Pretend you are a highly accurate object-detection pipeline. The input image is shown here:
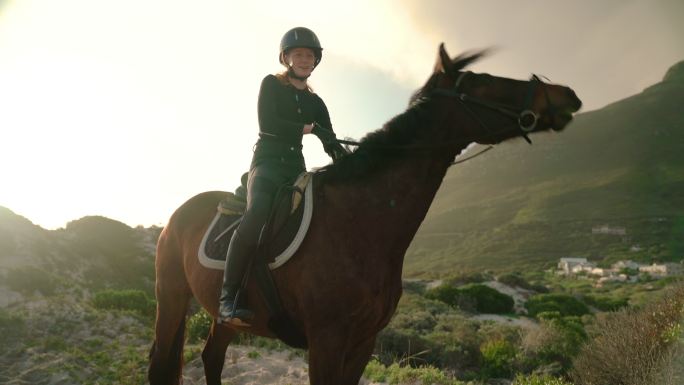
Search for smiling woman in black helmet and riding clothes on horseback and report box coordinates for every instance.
[219,27,346,326]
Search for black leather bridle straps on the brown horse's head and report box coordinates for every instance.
[431,71,553,144]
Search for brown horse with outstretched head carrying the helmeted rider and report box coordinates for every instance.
[149,45,581,385]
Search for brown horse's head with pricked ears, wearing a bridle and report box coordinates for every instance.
[416,44,582,144]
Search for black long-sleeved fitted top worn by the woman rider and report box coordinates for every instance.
[251,75,332,170]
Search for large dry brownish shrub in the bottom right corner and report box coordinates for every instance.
[571,284,684,385]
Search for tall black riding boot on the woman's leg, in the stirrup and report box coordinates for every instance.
[219,231,254,326]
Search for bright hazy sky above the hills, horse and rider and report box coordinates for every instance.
[0,0,684,229]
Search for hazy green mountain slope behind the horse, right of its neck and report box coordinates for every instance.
[405,62,684,276]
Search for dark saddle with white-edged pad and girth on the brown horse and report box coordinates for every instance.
[198,172,313,348]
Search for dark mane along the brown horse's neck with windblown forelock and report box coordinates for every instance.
[322,51,486,182]
